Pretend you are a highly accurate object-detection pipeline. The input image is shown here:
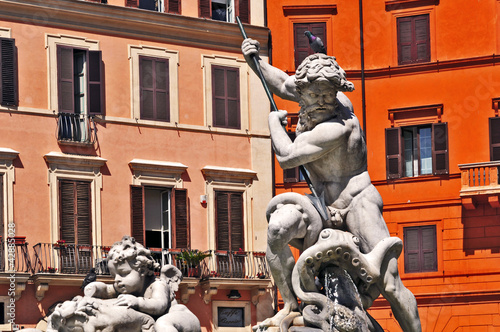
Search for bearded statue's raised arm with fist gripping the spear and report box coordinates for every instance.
[241,38,299,102]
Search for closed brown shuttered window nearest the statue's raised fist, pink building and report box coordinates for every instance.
[212,66,241,129]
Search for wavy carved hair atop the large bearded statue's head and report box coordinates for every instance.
[295,53,354,94]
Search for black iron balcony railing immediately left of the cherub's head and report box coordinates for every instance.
[33,242,110,275]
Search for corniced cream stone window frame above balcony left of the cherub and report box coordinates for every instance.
[44,152,107,245]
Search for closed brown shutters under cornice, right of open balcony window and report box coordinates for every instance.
[215,191,245,251]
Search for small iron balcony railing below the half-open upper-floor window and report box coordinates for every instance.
[57,113,96,144]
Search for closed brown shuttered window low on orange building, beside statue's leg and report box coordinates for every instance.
[403,225,437,273]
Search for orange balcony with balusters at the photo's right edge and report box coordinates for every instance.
[458,161,500,210]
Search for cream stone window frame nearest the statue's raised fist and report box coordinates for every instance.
[201,54,250,134]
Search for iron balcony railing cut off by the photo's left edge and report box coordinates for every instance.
[0,236,33,273]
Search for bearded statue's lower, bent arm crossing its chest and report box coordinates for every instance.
[269,111,350,169]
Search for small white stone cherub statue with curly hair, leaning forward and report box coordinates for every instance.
[47,236,201,332]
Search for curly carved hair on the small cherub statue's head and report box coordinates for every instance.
[108,236,160,276]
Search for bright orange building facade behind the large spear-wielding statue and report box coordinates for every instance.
[267,0,500,331]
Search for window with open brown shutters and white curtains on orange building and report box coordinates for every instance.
[386,123,448,179]
